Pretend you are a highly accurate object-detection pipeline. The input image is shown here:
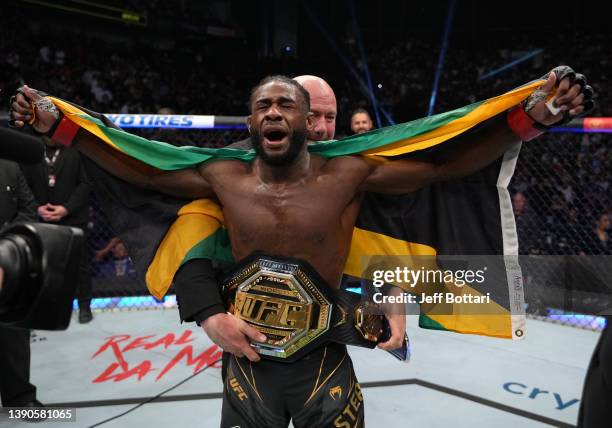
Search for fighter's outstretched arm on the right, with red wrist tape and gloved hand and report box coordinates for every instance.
[360,67,592,194]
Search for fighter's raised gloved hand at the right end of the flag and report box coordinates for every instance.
[525,66,594,126]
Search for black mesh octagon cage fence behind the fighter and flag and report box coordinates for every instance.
[80,114,612,330]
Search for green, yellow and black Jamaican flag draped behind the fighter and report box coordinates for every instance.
[50,80,544,338]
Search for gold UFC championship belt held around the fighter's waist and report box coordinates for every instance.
[222,253,408,362]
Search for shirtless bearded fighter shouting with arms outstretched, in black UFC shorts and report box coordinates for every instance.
[13,69,585,428]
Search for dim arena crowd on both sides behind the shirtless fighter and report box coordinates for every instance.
[0,2,612,292]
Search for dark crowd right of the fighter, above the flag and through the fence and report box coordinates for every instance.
[340,33,612,255]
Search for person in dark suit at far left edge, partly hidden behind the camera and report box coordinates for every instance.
[0,159,42,407]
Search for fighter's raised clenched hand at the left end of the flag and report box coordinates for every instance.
[10,85,57,134]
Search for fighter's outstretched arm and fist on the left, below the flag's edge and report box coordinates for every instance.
[11,86,213,199]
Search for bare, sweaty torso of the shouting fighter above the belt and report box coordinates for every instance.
[205,156,367,287]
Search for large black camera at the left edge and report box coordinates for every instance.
[0,223,85,330]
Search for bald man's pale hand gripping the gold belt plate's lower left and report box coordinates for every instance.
[202,313,266,362]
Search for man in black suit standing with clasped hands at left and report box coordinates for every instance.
[22,138,93,323]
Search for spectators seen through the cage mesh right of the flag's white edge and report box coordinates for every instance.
[510,133,612,255]
